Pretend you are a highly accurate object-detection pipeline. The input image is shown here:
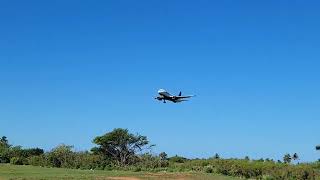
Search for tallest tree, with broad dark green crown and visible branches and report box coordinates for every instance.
[92,128,152,166]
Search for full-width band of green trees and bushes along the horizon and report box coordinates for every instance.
[0,129,320,179]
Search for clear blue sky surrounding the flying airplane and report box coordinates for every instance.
[0,0,320,161]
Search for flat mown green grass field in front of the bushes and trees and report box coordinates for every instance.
[0,164,235,180]
